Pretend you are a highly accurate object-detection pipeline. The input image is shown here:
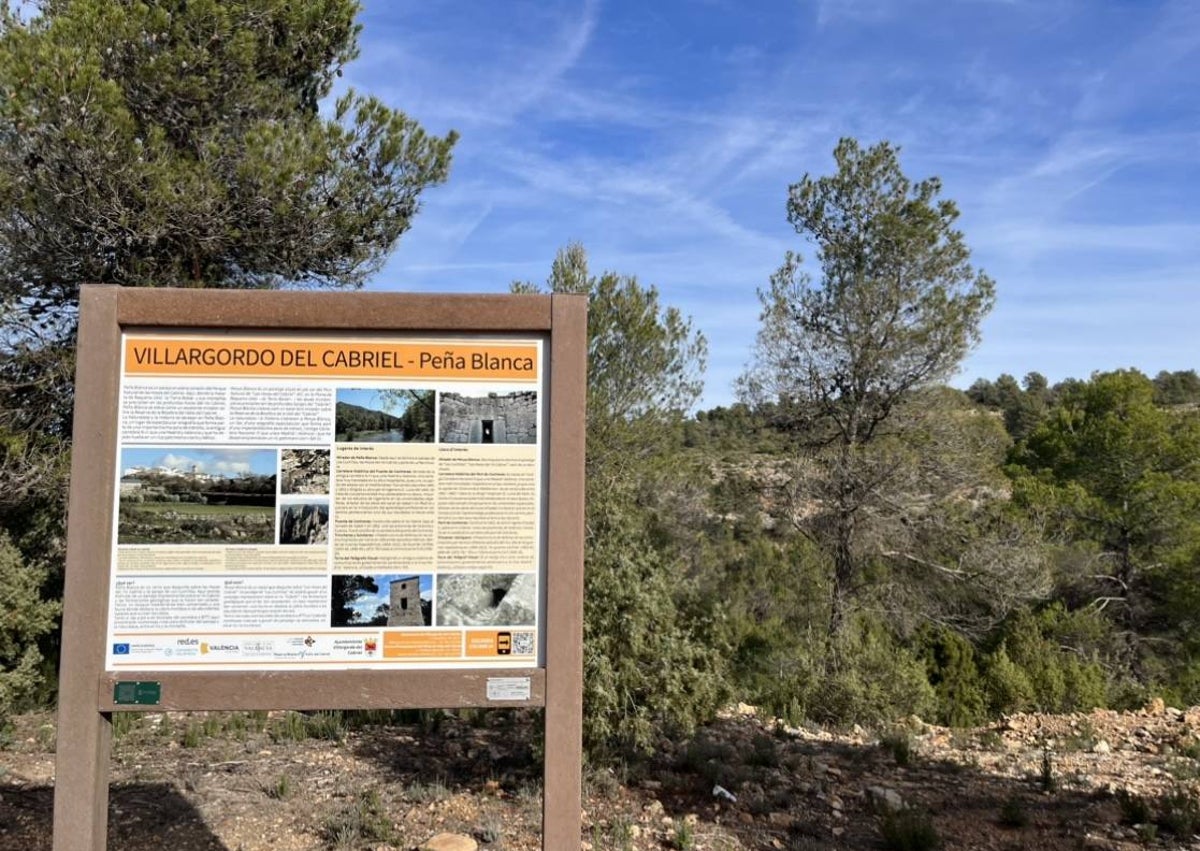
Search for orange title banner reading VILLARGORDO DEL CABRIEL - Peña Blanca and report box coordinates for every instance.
[125,337,538,382]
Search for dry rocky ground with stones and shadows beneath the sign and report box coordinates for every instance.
[0,703,1200,851]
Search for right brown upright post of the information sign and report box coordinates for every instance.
[541,295,588,850]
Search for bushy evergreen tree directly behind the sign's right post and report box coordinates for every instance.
[512,244,724,755]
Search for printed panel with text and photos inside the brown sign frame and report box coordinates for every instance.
[106,331,547,672]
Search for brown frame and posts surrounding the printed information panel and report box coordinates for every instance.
[53,286,587,851]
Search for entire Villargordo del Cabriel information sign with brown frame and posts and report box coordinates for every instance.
[53,286,587,851]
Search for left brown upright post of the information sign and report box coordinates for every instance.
[54,287,120,851]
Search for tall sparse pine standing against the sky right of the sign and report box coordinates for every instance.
[740,139,994,661]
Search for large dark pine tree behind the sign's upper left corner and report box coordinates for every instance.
[0,0,456,700]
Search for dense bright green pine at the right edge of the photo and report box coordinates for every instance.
[1013,370,1200,681]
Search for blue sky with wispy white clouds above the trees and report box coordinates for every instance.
[344,0,1200,406]
